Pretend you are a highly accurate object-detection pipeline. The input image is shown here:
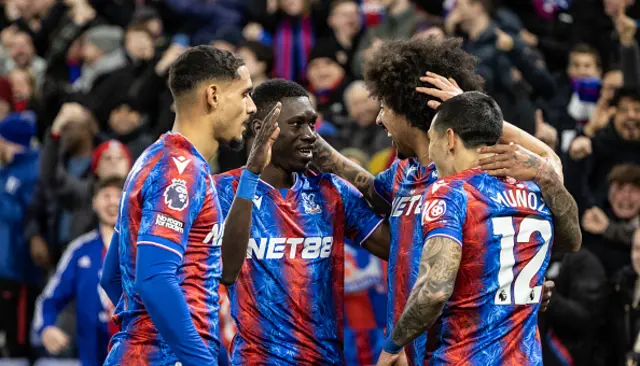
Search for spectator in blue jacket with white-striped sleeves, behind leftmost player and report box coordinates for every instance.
[33,176,124,365]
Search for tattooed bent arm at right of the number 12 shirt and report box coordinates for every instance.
[536,165,582,252]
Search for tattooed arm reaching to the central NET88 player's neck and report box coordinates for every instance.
[313,135,391,215]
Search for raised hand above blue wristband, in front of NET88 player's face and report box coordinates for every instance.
[247,102,282,174]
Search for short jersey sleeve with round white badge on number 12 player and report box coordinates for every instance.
[422,181,467,246]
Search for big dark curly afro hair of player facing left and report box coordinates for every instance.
[364,38,484,131]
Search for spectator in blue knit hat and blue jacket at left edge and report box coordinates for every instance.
[0,112,40,357]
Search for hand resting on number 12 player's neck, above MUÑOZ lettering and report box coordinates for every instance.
[478,143,555,181]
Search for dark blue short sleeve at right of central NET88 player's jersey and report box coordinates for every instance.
[334,177,383,245]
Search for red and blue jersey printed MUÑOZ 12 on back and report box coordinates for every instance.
[422,169,553,366]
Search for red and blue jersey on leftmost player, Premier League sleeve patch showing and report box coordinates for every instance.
[106,133,222,365]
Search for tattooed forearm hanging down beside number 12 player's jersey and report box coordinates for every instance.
[392,237,462,346]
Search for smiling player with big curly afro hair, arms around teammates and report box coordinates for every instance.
[313,38,559,365]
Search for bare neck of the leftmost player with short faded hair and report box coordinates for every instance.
[172,112,219,161]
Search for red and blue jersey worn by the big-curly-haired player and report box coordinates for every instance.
[374,158,437,365]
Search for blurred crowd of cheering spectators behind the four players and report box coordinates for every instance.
[0,0,640,365]
